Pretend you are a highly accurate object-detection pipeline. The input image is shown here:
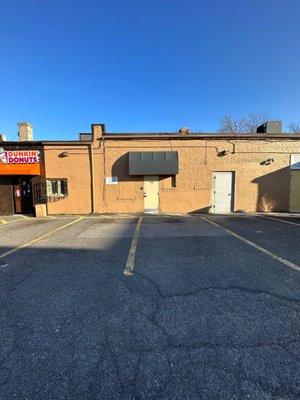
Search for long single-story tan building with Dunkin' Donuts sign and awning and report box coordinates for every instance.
[0,123,300,214]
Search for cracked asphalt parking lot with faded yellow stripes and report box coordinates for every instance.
[0,215,300,400]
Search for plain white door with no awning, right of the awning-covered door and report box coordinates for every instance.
[212,172,234,214]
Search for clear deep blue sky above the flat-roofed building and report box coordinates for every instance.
[0,0,300,139]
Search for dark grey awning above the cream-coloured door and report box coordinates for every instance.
[129,151,178,175]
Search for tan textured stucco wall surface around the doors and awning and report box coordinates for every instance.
[45,138,300,214]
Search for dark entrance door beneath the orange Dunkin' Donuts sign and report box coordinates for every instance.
[14,177,33,214]
